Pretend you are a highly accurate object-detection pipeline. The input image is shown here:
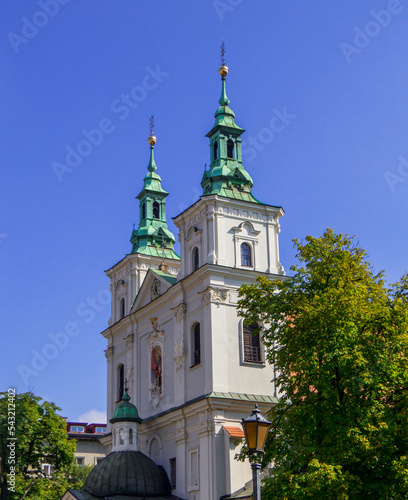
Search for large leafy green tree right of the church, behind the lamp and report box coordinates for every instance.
[239,229,408,500]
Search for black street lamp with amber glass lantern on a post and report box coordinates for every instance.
[242,405,271,500]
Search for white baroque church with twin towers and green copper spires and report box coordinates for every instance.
[102,65,284,500]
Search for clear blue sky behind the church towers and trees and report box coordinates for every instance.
[0,0,408,420]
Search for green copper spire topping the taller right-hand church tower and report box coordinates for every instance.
[201,47,259,203]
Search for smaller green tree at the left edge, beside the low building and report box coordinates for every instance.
[0,392,75,500]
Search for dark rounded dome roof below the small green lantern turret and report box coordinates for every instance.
[84,451,171,498]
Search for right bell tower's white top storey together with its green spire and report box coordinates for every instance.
[173,55,284,277]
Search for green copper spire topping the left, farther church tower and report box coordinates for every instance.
[130,120,180,260]
